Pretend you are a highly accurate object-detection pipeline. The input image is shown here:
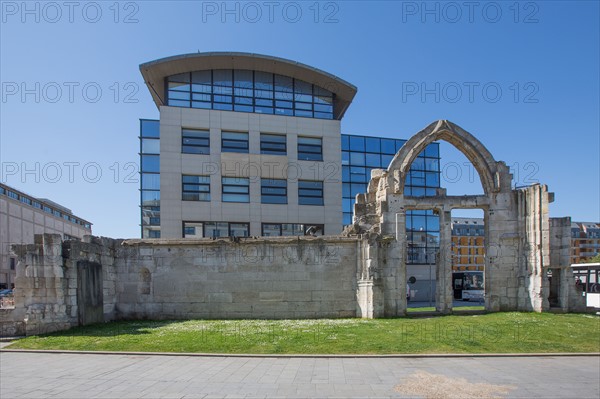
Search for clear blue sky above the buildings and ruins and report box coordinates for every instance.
[0,1,600,237]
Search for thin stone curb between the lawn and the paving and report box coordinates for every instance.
[0,349,600,359]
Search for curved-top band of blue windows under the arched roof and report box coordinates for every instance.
[166,69,334,119]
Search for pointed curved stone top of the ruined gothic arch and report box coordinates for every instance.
[387,120,510,195]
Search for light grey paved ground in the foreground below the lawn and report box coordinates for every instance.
[0,352,600,399]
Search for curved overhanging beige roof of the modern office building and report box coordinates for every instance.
[140,52,357,119]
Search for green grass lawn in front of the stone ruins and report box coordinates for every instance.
[8,312,600,354]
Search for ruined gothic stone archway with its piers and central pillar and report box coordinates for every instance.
[346,120,580,317]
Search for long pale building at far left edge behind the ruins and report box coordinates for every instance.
[0,184,92,289]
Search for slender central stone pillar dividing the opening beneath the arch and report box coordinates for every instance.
[435,209,454,313]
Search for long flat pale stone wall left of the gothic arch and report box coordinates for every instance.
[114,237,358,319]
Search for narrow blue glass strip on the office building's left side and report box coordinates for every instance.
[140,119,160,238]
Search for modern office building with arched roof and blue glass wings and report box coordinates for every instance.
[140,53,440,241]
